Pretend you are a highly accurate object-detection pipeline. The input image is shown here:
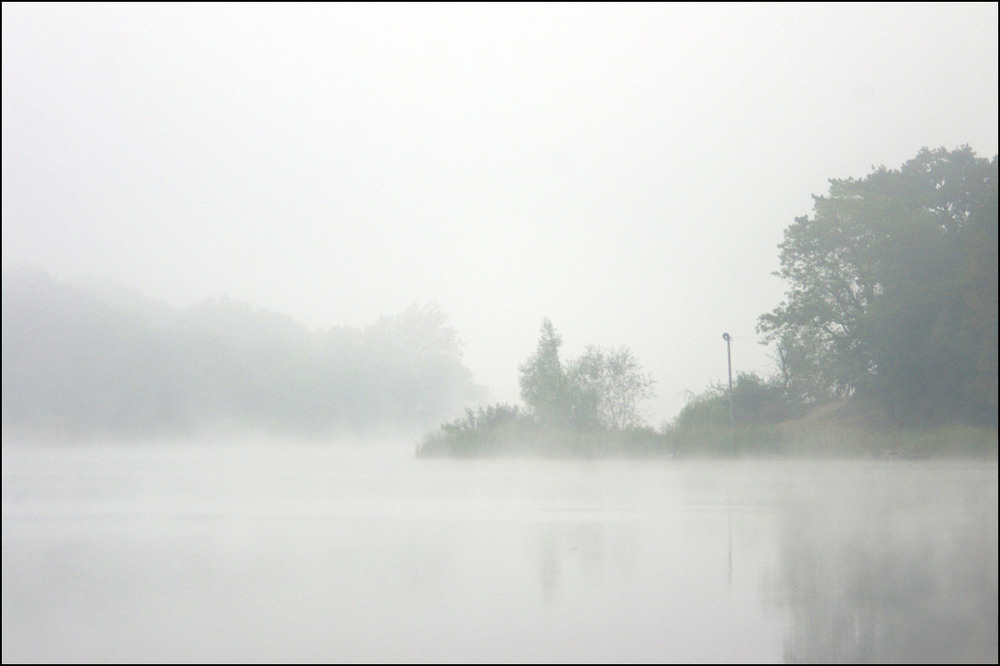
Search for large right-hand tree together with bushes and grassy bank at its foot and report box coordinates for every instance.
[664,147,997,456]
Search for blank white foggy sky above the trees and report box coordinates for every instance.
[3,3,998,424]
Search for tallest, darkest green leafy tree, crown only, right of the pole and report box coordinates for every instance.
[758,146,997,423]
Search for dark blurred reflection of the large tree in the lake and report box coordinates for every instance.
[770,465,998,663]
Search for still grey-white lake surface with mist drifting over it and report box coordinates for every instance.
[3,445,998,663]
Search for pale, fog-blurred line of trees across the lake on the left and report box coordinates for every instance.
[3,269,482,438]
